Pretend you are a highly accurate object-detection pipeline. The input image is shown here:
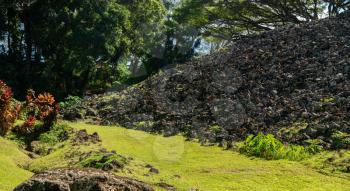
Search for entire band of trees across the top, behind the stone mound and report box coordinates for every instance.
[0,0,350,97]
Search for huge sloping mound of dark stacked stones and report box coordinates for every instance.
[63,13,350,147]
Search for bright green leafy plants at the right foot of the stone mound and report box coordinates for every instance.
[240,133,322,161]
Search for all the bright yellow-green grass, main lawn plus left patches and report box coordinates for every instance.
[0,123,350,191]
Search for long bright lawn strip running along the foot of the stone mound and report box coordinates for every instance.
[62,123,350,191]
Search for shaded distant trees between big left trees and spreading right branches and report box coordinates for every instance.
[137,0,201,76]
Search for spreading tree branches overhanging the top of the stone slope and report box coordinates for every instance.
[176,0,350,40]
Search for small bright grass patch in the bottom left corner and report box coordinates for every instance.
[0,137,32,191]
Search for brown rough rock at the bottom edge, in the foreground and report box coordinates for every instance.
[14,169,153,191]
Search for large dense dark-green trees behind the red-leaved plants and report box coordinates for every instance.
[0,0,164,97]
